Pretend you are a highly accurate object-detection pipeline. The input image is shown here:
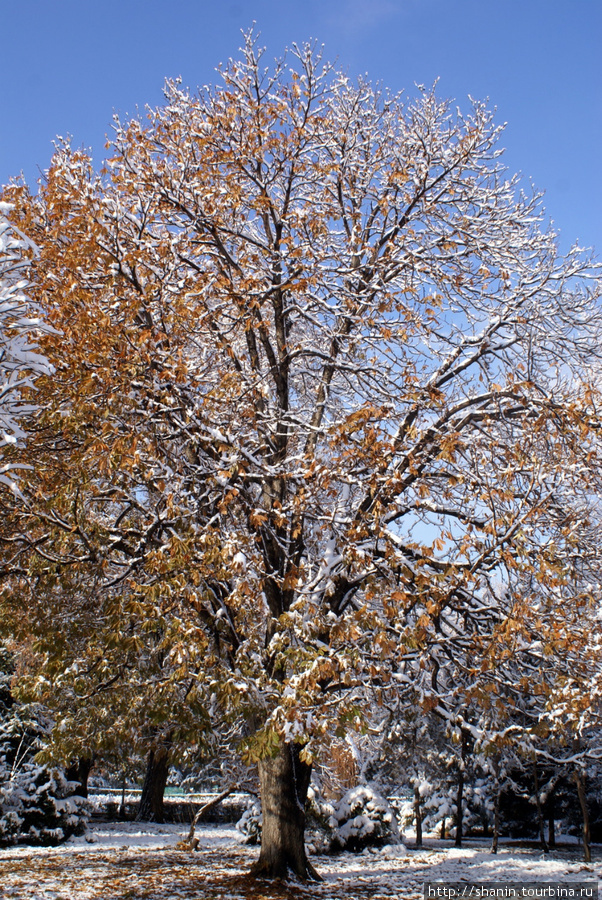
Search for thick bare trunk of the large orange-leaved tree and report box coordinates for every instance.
[251,744,320,881]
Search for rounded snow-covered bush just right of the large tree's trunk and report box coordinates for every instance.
[330,785,399,852]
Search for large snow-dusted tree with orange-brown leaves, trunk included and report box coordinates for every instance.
[2,37,600,877]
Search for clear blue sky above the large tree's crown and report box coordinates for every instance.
[0,0,602,255]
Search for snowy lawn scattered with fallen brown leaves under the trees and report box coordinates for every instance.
[0,823,602,900]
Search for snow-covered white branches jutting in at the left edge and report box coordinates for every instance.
[0,203,51,487]
